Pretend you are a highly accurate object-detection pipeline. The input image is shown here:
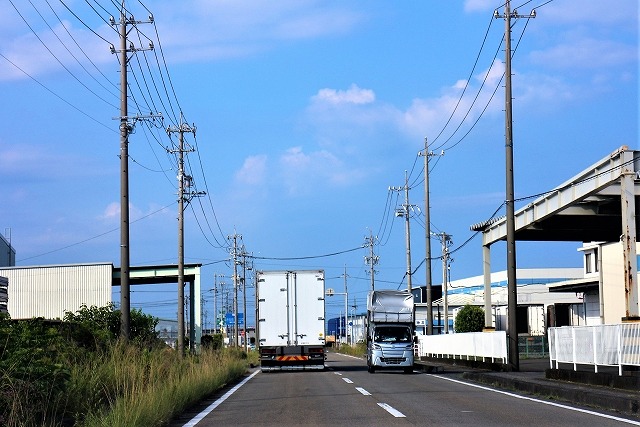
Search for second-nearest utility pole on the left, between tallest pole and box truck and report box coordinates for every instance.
[167,114,196,355]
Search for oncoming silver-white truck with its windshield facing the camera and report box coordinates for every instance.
[367,290,415,374]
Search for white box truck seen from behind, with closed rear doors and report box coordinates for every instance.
[256,270,325,371]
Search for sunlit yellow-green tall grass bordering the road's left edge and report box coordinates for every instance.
[77,346,248,427]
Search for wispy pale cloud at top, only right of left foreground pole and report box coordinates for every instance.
[154,0,364,62]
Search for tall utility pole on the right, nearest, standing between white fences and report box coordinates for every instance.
[493,0,536,371]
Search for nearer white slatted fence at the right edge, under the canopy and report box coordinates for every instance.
[549,323,640,375]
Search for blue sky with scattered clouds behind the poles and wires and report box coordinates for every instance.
[0,0,639,328]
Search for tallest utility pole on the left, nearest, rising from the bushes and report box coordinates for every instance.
[109,5,153,341]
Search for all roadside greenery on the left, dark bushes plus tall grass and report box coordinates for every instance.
[0,306,253,427]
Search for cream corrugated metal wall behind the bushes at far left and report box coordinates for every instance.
[0,264,113,319]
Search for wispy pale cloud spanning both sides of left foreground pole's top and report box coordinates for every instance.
[0,0,364,80]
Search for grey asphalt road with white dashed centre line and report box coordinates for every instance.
[172,354,640,427]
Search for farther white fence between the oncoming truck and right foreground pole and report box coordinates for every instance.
[417,331,507,363]
